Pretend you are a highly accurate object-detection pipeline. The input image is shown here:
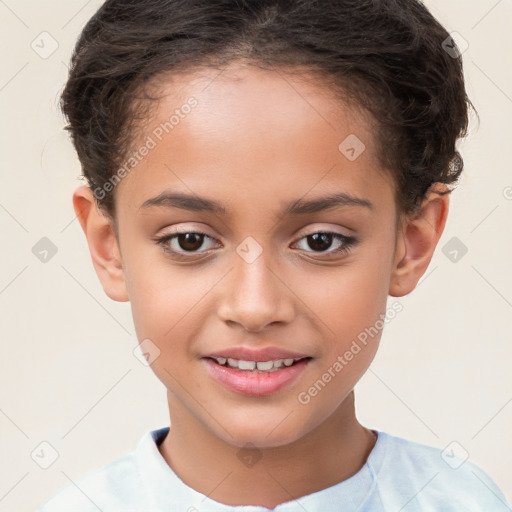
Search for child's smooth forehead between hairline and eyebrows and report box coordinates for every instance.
[116,65,391,215]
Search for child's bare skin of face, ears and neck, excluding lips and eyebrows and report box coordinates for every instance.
[73,64,449,508]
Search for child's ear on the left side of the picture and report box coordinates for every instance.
[73,185,129,302]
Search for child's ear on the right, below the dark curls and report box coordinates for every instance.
[389,183,450,297]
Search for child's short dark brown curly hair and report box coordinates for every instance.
[60,0,476,218]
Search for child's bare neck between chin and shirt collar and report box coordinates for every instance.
[159,392,376,508]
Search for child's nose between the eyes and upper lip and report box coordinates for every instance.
[218,250,295,332]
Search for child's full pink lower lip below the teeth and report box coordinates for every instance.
[204,358,310,396]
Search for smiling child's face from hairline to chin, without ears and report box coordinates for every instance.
[115,66,400,447]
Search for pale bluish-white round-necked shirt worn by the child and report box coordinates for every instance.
[38,427,512,512]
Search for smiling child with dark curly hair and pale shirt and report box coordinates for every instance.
[41,0,510,512]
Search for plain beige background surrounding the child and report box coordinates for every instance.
[0,0,512,512]
